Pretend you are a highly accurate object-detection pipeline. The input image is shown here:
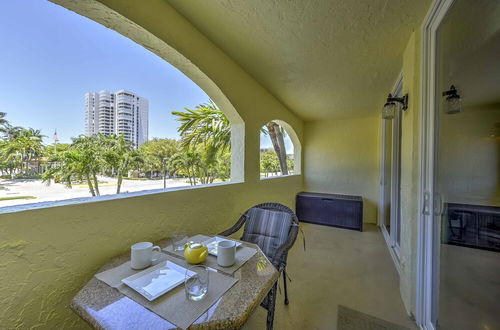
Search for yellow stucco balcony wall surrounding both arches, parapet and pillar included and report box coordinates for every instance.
[0,0,303,329]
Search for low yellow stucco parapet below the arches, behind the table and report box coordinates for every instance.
[0,176,302,329]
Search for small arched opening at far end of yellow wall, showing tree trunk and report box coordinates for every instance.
[260,120,301,178]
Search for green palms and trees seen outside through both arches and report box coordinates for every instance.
[0,101,293,196]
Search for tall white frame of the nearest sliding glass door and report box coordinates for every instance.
[415,0,455,330]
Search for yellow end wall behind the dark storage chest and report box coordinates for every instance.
[304,112,380,223]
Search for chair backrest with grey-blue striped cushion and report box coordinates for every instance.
[242,203,298,260]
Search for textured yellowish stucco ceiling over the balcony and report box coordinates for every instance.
[166,0,430,120]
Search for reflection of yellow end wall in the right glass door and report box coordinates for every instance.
[437,104,500,206]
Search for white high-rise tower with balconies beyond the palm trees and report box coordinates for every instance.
[85,90,149,148]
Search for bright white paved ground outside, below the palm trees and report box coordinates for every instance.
[0,177,189,207]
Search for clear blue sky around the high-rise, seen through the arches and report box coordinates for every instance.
[0,0,291,149]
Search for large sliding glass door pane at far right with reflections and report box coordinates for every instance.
[432,0,500,330]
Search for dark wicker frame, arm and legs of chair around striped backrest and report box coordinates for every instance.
[219,203,299,329]
